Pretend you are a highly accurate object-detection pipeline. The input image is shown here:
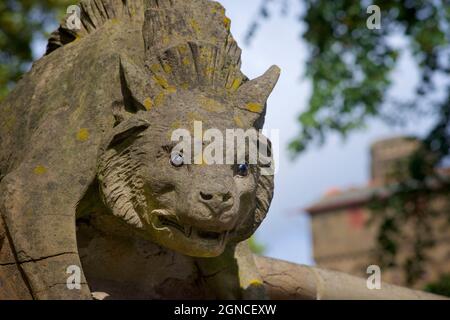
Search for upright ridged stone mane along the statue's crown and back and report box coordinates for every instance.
[47,0,248,90]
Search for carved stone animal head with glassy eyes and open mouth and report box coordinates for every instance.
[98,63,278,257]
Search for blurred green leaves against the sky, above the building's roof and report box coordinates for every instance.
[247,0,450,154]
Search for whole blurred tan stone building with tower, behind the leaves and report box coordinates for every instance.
[306,137,450,288]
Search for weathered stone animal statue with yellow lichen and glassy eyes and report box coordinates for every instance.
[0,0,279,299]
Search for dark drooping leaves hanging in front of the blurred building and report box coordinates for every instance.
[370,175,450,286]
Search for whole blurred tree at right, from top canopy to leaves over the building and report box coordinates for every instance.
[247,0,450,284]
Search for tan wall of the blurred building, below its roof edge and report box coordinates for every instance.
[312,197,450,289]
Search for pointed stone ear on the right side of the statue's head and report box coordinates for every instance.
[236,66,280,129]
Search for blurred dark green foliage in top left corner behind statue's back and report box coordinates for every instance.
[0,0,74,100]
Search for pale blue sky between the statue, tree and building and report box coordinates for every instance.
[34,0,427,264]
